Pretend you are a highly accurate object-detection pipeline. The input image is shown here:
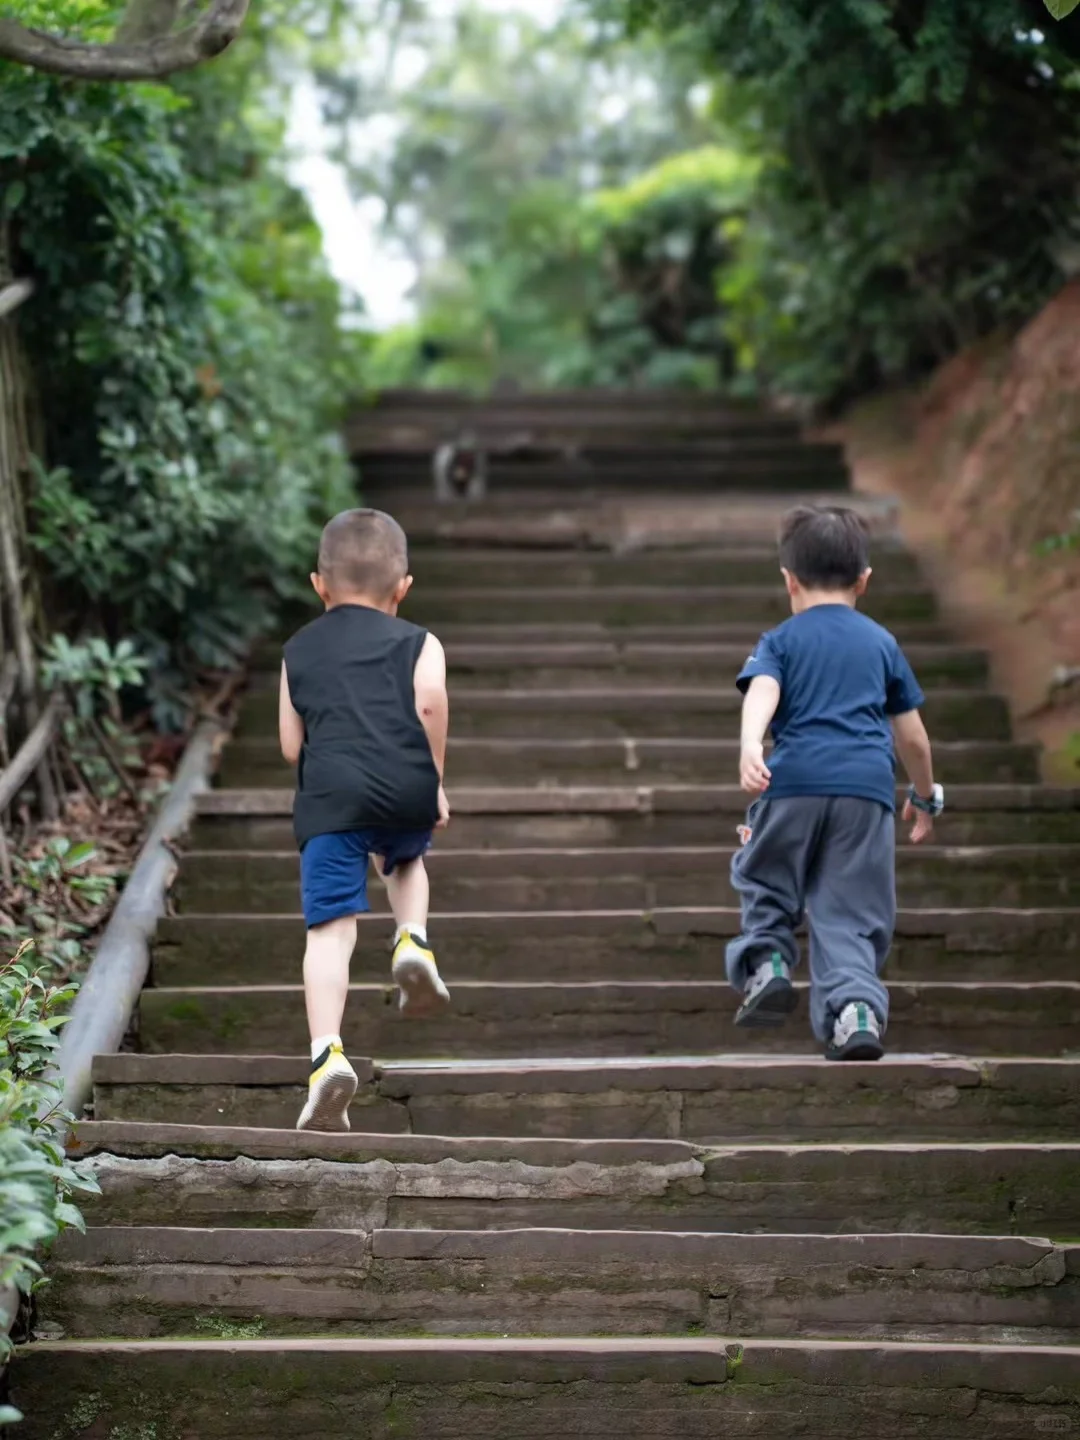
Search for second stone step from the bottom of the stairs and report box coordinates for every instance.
[40,1227,1080,1344]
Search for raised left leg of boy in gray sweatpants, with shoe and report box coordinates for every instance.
[727,795,824,1027]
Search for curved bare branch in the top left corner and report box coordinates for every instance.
[0,0,249,81]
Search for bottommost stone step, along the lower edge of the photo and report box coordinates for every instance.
[13,1338,1080,1440]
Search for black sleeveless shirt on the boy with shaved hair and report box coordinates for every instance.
[285,605,439,848]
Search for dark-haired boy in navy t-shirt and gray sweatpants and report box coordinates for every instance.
[727,507,943,1060]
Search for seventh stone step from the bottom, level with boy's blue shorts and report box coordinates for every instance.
[173,831,1080,916]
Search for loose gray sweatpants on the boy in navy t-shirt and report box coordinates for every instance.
[727,795,896,1041]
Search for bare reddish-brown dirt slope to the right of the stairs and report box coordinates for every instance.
[834,281,1080,783]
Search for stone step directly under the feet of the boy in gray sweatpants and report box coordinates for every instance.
[94,1054,1080,1143]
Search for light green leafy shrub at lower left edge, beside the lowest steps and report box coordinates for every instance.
[0,943,98,1382]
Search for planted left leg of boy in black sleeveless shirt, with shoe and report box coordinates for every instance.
[297,834,367,1130]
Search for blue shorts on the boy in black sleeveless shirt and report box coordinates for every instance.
[300,825,432,930]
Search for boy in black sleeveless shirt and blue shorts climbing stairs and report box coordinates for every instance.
[279,510,449,1130]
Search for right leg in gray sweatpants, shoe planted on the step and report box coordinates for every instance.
[806,795,896,1060]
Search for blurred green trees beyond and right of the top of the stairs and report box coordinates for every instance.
[342,0,1080,403]
